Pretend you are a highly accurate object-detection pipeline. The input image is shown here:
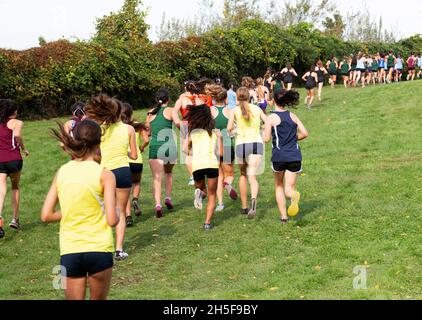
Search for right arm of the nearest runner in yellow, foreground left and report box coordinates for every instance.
[100,169,120,227]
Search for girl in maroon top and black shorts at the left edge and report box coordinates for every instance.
[0,99,29,239]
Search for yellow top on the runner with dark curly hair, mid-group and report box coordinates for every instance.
[190,129,219,172]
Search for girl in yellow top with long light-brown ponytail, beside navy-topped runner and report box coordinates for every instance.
[227,87,267,219]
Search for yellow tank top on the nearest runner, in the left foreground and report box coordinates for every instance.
[57,161,114,256]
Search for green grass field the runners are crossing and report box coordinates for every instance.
[0,81,422,300]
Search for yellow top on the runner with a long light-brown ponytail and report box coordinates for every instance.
[234,104,263,146]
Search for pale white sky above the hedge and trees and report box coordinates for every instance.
[0,0,422,50]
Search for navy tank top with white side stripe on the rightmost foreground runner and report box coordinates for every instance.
[272,111,302,163]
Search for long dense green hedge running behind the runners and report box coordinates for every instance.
[0,20,422,119]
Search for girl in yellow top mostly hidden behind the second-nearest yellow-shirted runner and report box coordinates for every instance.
[122,103,149,227]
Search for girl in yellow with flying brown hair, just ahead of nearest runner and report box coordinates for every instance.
[85,94,138,261]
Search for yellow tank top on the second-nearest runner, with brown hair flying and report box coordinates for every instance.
[101,122,129,170]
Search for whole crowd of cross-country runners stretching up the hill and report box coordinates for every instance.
[0,52,422,299]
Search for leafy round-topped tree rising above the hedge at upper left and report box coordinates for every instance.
[94,0,149,43]
